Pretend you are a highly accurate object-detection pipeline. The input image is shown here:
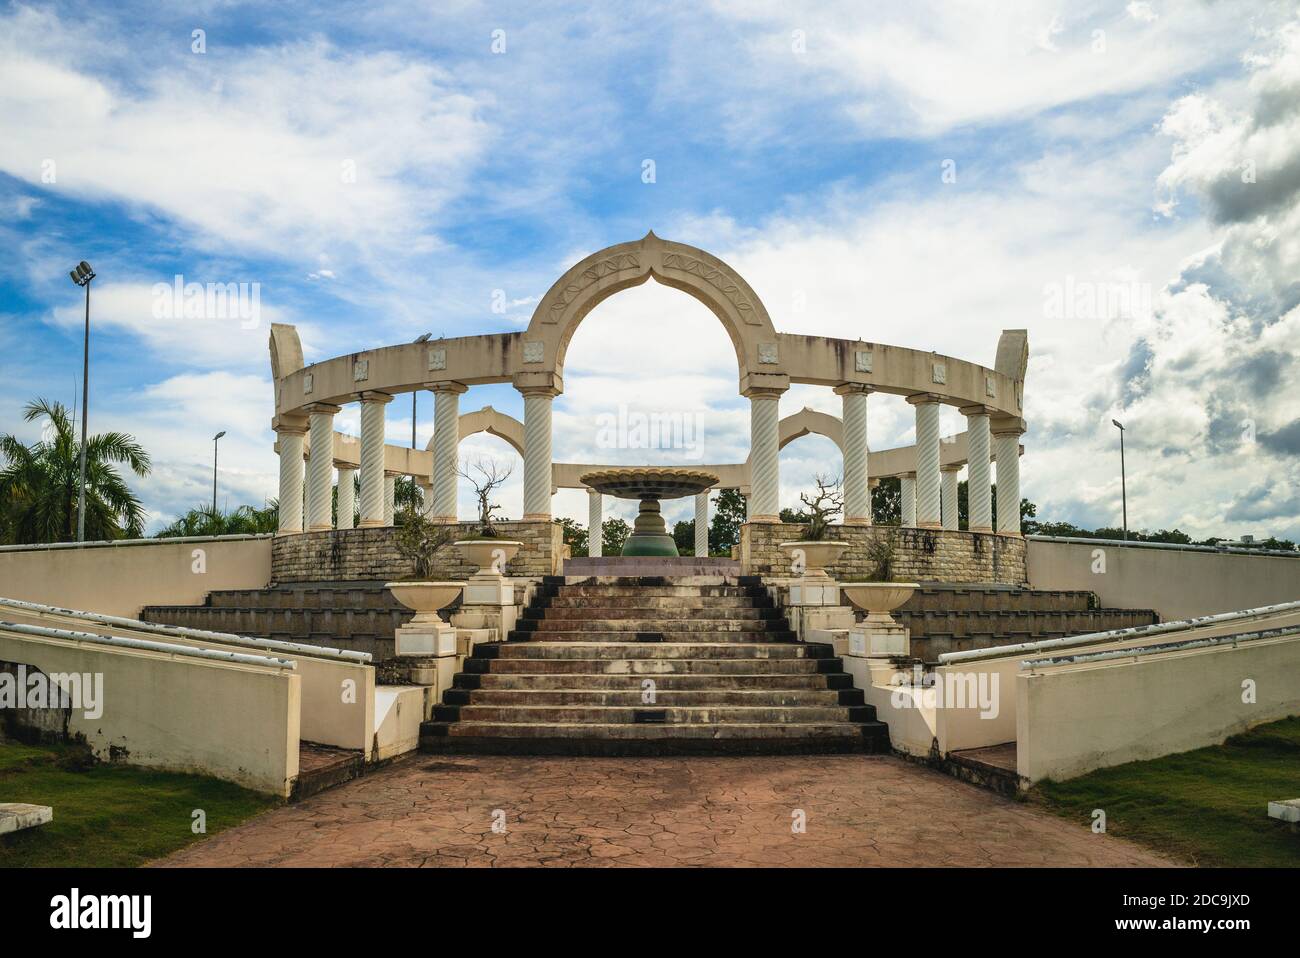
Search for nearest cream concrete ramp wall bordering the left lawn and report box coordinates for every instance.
[0,623,302,796]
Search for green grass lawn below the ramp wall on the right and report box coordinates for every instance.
[1030,716,1300,867]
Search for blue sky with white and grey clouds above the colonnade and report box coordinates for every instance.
[0,0,1300,538]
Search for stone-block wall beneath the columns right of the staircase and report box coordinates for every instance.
[740,523,1028,586]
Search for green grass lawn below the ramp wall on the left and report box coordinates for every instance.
[0,741,278,868]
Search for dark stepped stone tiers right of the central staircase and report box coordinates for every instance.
[894,585,1160,662]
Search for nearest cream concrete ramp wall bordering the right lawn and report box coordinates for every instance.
[1015,627,1300,783]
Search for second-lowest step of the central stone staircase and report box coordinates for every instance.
[434,705,876,725]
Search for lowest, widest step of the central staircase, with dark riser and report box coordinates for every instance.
[420,721,889,755]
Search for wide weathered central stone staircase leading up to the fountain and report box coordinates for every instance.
[420,576,889,755]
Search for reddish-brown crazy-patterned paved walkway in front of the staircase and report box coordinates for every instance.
[160,755,1171,867]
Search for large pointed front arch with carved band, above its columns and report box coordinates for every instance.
[524,230,781,381]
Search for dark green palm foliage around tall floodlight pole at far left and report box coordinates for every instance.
[0,399,150,542]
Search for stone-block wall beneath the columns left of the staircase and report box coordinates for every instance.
[270,521,563,585]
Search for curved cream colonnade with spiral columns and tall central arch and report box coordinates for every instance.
[270,233,1028,536]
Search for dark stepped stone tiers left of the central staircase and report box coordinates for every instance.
[140,582,415,662]
